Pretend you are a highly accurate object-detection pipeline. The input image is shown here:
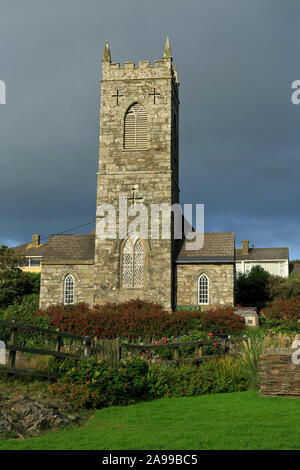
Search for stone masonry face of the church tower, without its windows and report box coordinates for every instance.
[94,54,179,308]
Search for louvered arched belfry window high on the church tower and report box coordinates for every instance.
[124,103,147,150]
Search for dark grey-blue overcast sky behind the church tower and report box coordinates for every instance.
[0,0,300,259]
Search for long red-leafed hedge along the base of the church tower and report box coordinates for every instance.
[37,300,201,340]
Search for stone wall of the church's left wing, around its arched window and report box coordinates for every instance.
[40,261,94,308]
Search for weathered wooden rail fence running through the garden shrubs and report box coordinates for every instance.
[0,320,229,378]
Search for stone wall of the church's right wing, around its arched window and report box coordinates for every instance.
[177,264,234,310]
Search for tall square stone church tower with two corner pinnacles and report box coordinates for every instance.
[94,39,179,309]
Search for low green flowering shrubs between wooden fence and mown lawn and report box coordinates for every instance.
[48,356,248,408]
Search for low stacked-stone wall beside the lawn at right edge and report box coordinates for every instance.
[259,348,300,397]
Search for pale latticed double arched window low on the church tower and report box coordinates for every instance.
[122,238,145,287]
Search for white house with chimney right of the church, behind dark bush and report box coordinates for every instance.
[235,240,289,277]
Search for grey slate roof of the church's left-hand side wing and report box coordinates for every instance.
[43,234,95,262]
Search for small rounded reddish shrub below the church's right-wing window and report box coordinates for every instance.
[201,306,246,336]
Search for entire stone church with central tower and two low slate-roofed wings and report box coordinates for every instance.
[40,39,235,310]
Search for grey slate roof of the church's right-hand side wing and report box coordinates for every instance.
[176,232,235,264]
